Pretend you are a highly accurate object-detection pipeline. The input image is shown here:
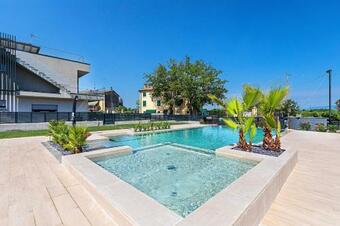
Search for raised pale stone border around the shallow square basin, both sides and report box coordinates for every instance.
[62,140,297,226]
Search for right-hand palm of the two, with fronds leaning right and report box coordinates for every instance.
[259,86,289,150]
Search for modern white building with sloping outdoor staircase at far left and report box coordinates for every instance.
[0,33,98,112]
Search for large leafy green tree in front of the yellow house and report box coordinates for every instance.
[146,57,227,114]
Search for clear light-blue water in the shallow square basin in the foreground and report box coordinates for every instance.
[93,144,257,217]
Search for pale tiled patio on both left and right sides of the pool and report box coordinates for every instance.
[0,128,340,226]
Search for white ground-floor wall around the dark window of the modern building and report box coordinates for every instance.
[18,97,88,112]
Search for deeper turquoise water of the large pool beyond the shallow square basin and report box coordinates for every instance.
[92,126,263,150]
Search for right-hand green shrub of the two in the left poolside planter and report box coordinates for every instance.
[63,126,90,153]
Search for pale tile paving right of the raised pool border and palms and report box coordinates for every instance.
[261,131,340,226]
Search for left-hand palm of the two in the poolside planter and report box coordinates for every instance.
[208,85,262,150]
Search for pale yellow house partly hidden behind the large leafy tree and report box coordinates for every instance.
[139,85,189,115]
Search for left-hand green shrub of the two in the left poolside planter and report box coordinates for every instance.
[48,120,69,147]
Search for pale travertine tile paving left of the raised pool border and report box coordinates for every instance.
[0,137,117,226]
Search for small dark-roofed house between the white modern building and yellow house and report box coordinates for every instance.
[80,88,123,113]
